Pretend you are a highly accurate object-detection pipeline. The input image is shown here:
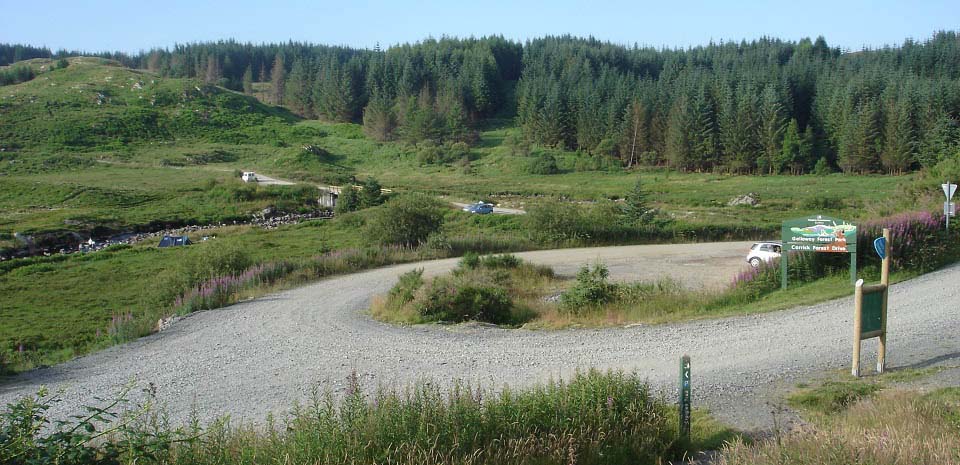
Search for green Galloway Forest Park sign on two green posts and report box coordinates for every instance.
[780,215,857,289]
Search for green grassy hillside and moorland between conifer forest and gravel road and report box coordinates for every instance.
[0,58,928,374]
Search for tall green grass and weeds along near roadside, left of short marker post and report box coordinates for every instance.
[0,371,685,465]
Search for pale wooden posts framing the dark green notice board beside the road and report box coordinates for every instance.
[850,229,890,376]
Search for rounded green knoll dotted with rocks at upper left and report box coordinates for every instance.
[0,57,296,151]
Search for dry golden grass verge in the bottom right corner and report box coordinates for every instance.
[717,372,960,465]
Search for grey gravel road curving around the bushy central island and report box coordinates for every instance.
[0,243,960,429]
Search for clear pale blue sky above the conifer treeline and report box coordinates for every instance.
[0,0,960,53]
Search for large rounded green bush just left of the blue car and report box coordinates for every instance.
[366,194,443,247]
